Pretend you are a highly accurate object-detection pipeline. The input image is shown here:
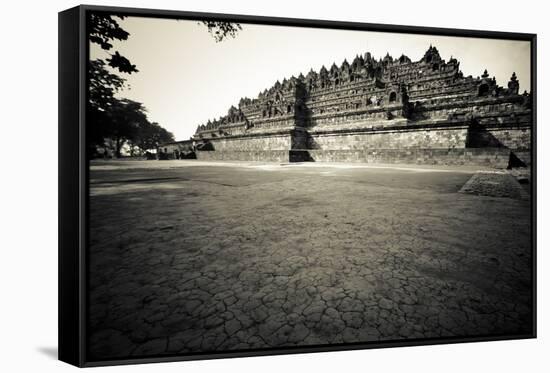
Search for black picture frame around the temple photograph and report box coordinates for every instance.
[58,5,537,367]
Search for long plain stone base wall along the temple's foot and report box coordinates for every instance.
[197,124,530,168]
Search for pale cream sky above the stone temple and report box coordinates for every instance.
[90,17,530,140]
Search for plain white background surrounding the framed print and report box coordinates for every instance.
[0,0,550,373]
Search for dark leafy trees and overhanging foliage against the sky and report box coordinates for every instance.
[87,13,241,157]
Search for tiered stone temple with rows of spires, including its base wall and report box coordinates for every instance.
[188,46,532,168]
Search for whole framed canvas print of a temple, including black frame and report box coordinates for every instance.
[59,6,536,366]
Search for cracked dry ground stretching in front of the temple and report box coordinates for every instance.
[88,162,532,359]
